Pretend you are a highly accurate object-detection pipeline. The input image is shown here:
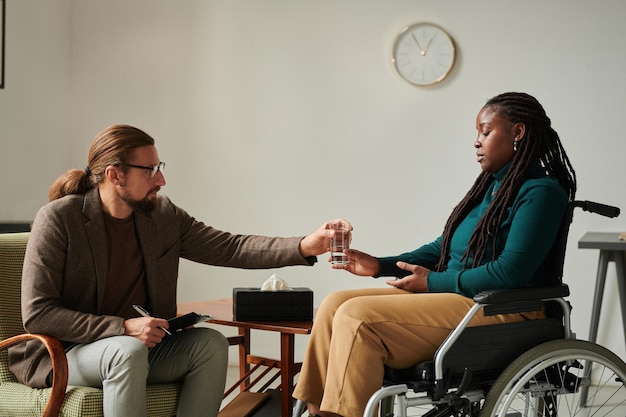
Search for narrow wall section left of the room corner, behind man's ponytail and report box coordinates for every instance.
[0,0,73,221]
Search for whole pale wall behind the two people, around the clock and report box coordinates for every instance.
[0,0,626,357]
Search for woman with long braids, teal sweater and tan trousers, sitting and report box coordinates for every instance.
[294,93,576,416]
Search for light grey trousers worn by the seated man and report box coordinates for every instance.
[67,328,228,417]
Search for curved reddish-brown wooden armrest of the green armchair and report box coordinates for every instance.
[0,333,68,417]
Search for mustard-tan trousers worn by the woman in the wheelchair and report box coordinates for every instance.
[293,287,544,417]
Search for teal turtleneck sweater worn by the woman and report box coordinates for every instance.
[378,165,568,297]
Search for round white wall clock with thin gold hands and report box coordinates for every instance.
[392,23,455,86]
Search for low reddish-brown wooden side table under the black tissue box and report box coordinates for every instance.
[178,298,313,417]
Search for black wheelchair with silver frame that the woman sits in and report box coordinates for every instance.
[293,200,626,417]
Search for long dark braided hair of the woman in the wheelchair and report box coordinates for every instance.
[436,93,576,271]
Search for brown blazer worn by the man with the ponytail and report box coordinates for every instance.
[9,188,316,387]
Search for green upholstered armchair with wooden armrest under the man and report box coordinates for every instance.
[0,233,181,417]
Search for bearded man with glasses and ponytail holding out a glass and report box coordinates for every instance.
[9,125,346,417]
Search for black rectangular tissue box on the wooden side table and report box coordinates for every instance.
[233,287,313,321]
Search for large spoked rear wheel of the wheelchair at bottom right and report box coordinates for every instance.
[480,339,626,417]
